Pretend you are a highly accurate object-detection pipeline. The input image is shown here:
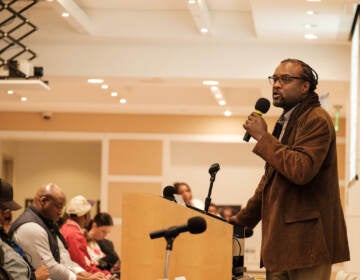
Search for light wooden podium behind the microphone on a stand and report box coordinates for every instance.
[121,193,233,280]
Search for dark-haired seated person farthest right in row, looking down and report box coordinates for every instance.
[87,213,120,274]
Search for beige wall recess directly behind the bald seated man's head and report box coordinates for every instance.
[3,141,101,220]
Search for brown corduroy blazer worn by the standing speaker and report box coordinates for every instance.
[236,107,350,271]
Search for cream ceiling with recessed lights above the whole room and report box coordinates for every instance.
[0,0,358,115]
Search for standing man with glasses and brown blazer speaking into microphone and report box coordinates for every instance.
[231,59,350,280]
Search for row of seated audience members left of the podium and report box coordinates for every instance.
[0,179,120,280]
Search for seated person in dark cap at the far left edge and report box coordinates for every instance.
[0,179,49,280]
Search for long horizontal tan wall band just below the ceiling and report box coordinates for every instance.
[0,112,248,134]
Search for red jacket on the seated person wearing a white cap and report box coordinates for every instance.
[60,218,110,274]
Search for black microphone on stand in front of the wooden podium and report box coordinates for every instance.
[150,216,206,239]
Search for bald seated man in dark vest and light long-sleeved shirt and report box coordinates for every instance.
[9,183,108,280]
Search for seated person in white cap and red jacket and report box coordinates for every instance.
[60,195,109,275]
